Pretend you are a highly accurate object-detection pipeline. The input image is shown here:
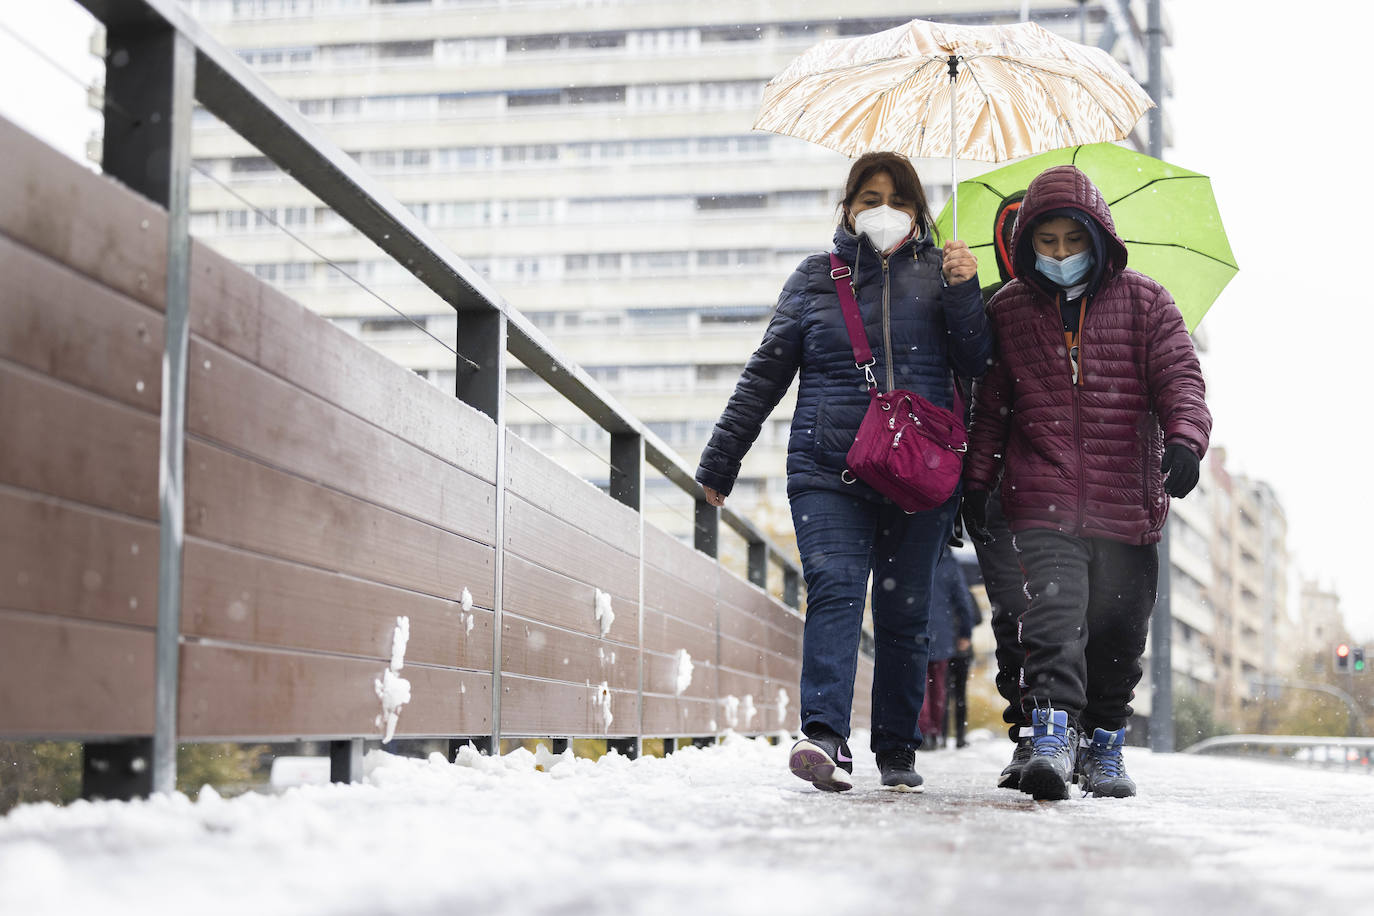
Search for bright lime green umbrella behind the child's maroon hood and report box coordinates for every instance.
[936,143,1237,331]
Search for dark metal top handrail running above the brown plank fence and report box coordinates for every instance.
[78,0,801,590]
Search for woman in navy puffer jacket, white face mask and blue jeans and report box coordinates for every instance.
[697,152,992,791]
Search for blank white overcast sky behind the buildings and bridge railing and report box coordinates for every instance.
[8,0,1374,641]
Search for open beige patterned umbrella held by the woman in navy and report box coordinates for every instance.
[754,19,1154,238]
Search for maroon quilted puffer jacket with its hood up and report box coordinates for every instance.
[965,165,1212,544]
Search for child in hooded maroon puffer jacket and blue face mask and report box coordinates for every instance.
[963,166,1212,799]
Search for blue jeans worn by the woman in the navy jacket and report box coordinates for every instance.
[791,490,959,753]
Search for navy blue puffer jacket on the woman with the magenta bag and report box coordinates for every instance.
[697,224,992,500]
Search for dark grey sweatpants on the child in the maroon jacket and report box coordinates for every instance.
[1014,529,1160,735]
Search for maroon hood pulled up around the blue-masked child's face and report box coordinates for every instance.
[1011,165,1127,299]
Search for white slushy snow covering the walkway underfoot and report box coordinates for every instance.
[0,735,1374,916]
